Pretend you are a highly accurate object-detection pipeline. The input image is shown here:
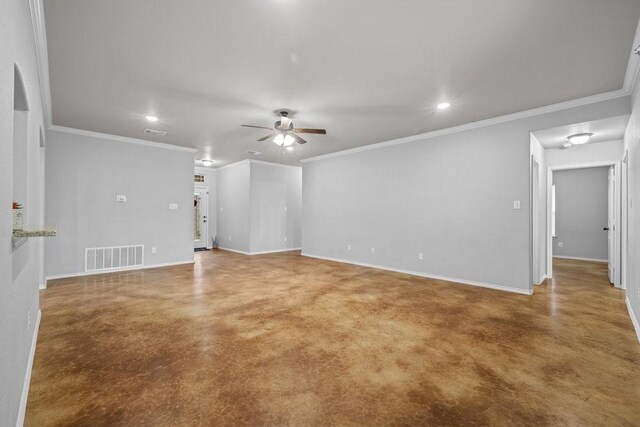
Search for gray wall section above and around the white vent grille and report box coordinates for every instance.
[45,131,194,277]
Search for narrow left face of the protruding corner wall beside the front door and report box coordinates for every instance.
[217,160,251,252]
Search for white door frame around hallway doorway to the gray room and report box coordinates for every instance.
[546,160,627,288]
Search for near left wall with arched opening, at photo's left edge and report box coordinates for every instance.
[0,0,45,425]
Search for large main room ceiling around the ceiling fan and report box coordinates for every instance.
[44,0,640,167]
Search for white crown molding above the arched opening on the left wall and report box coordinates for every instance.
[29,0,53,127]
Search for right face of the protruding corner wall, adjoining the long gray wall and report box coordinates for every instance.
[250,161,302,253]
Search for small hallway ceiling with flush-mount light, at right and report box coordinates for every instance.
[532,115,629,148]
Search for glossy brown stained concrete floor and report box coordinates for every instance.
[26,251,640,426]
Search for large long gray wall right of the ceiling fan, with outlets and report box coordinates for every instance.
[302,97,630,292]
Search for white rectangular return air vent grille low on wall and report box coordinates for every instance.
[84,245,144,272]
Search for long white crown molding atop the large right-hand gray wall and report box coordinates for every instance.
[300,89,630,163]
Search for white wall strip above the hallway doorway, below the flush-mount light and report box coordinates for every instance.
[545,141,624,167]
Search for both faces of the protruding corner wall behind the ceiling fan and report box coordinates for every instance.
[217,160,302,254]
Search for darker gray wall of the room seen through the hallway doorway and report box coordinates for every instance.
[553,167,609,261]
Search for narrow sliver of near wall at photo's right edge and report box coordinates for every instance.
[622,72,640,339]
